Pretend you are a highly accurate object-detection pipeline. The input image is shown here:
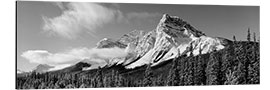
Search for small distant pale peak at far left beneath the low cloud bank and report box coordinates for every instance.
[33,64,54,73]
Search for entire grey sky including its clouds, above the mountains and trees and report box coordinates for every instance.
[16,1,260,71]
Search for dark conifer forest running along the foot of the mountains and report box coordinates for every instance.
[16,29,260,89]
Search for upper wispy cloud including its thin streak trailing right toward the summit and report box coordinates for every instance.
[43,2,161,39]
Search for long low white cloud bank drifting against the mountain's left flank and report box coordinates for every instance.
[21,47,127,68]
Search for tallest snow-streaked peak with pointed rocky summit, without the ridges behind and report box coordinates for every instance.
[126,14,230,68]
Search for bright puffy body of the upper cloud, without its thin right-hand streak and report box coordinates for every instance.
[43,2,121,39]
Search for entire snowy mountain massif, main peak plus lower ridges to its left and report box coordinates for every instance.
[94,14,230,69]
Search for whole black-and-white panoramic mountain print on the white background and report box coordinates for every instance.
[16,1,260,89]
